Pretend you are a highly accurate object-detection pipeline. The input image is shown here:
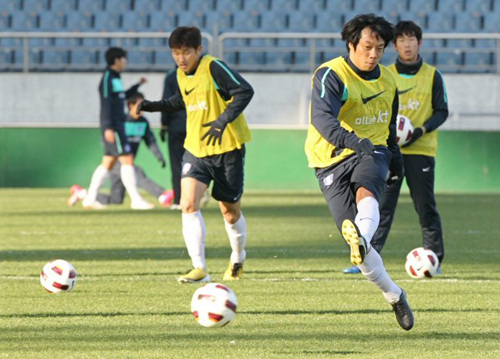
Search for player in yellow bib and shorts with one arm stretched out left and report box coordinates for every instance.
[138,27,253,283]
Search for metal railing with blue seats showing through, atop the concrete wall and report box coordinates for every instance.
[0,32,500,74]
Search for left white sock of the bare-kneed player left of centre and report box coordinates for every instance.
[182,211,207,269]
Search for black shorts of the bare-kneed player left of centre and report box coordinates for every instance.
[182,146,245,203]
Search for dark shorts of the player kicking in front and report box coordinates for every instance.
[316,147,392,228]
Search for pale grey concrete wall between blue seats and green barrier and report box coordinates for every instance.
[0,73,500,131]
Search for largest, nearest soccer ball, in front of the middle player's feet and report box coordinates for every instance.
[191,283,238,328]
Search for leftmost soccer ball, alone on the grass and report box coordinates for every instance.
[40,259,76,293]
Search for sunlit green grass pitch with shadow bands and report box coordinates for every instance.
[0,189,500,359]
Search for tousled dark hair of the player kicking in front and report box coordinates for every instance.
[340,14,394,51]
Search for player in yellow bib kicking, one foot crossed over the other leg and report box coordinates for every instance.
[305,14,414,330]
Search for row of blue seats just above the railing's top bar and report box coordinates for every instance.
[0,8,500,35]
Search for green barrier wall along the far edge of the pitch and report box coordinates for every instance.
[0,127,500,193]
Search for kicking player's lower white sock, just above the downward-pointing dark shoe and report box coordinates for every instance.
[358,249,401,303]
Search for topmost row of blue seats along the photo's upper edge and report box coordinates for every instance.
[2,0,500,13]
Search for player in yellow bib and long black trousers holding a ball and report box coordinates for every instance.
[372,21,448,274]
